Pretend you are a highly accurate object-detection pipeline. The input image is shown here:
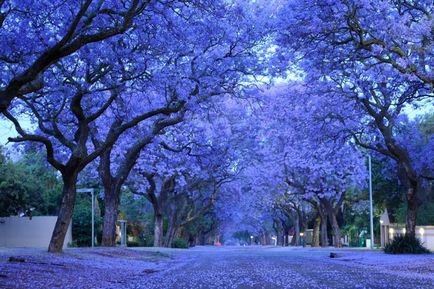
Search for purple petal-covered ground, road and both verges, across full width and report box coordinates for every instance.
[0,246,434,289]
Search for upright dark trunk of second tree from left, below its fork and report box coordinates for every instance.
[102,186,120,247]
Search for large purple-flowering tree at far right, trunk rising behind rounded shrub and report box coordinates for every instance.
[278,1,434,235]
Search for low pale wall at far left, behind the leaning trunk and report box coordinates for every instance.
[0,216,72,248]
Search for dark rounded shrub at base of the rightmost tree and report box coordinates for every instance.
[384,235,430,254]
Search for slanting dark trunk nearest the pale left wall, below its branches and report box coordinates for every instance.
[48,171,78,253]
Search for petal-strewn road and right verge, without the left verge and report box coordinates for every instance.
[133,247,434,289]
